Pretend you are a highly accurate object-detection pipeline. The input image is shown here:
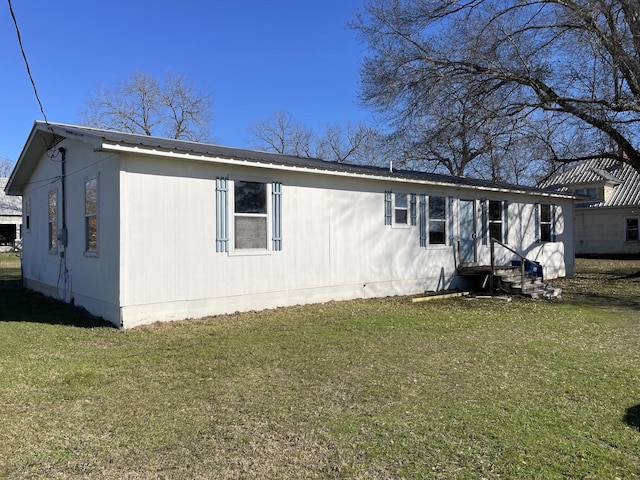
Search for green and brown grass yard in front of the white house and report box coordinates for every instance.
[0,260,640,479]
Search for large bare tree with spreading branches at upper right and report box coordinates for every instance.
[354,0,640,176]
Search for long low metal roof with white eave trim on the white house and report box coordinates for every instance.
[7,121,570,201]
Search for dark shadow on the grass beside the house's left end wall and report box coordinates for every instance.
[0,280,115,328]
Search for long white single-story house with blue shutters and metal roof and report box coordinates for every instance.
[6,122,574,328]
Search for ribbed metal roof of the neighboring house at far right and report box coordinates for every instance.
[541,158,640,207]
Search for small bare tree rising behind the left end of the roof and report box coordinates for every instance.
[82,72,212,141]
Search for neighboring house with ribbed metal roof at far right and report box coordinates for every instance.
[542,159,640,256]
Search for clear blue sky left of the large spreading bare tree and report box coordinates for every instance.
[0,0,371,161]
